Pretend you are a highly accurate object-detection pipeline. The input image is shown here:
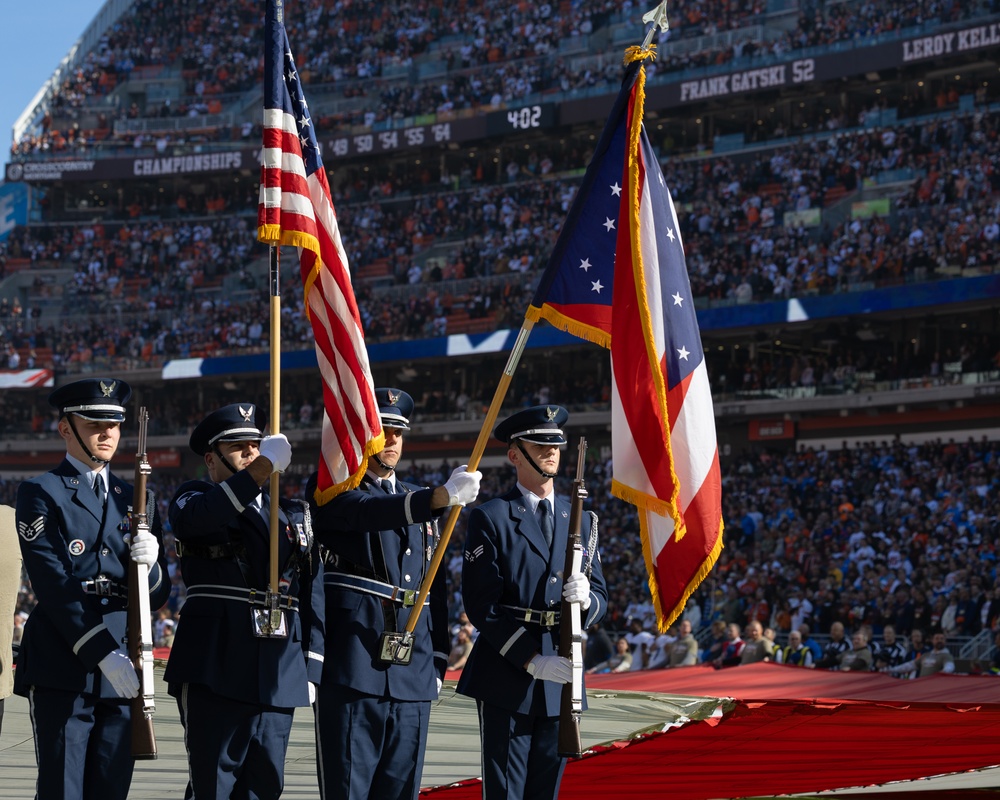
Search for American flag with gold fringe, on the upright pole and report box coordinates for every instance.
[257,0,385,504]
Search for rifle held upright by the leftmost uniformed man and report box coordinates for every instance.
[127,406,156,760]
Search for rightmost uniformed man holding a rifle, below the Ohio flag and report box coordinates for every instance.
[458,406,608,800]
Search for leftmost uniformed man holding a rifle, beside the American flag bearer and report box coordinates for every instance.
[14,378,170,800]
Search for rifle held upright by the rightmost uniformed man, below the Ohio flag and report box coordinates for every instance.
[559,437,587,758]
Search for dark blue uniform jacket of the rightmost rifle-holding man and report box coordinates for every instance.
[458,488,608,717]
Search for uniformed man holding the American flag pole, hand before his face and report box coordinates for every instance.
[164,403,322,800]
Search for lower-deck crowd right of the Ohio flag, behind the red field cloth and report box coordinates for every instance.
[592,440,1000,675]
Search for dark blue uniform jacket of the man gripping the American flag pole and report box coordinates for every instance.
[164,471,323,708]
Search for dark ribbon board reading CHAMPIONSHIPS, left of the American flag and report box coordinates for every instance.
[6,148,258,183]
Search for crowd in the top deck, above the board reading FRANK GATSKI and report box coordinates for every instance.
[11,0,998,156]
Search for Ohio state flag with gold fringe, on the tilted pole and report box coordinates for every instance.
[527,48,722,628]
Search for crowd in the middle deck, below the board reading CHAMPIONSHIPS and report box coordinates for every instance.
[0,97,1000,389]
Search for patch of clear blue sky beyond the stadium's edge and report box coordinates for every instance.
[0,0,104,153]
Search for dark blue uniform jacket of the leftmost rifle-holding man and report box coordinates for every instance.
[14,460,170,700]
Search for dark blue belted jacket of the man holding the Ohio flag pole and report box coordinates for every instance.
[313,476,450,701]
